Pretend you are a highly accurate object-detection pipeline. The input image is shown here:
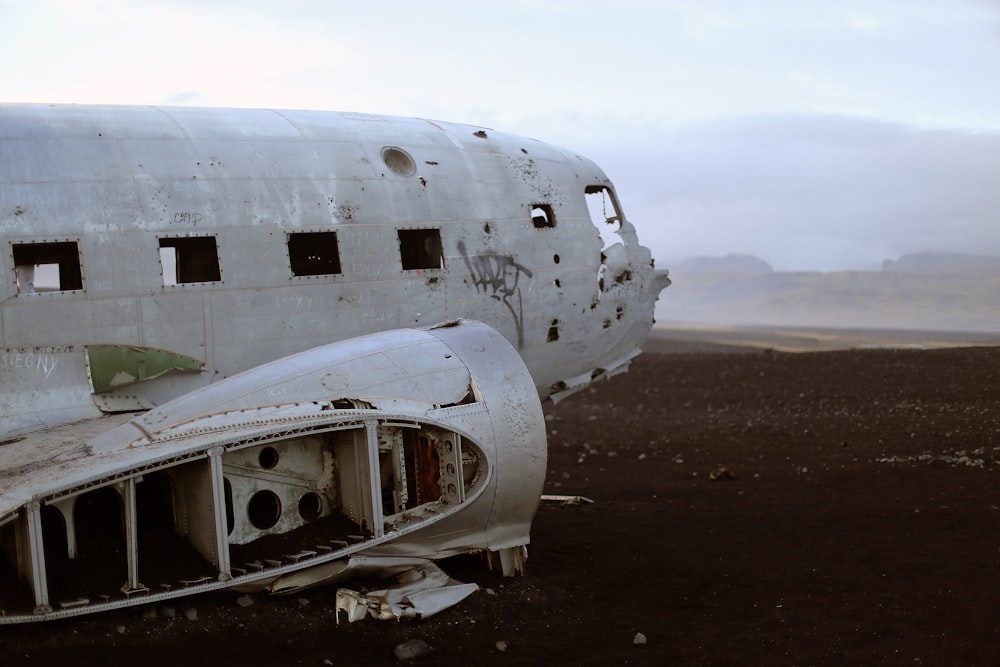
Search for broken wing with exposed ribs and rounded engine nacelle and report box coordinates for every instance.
[0,322,546,623]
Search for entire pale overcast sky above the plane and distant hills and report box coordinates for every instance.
[0,0,1000,270]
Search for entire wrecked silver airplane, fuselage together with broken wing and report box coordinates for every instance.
[0,104,669,623]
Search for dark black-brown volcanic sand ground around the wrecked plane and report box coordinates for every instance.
[0,343,1000,667]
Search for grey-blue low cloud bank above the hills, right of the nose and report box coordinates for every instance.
[619,115,1000,270]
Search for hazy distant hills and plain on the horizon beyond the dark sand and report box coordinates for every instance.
[656,252,1000,332]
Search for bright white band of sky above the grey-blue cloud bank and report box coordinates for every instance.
[7,0,1000,129]
